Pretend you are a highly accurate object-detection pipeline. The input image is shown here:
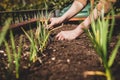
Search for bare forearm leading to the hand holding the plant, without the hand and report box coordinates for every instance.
[61,0,85,21]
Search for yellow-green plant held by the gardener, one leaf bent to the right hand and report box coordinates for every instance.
[35,10,62,53]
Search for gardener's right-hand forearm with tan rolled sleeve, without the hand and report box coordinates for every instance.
[79,0,116,28]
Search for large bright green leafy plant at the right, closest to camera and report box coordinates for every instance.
[85,10,120,80]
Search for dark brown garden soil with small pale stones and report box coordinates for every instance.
[0,21,120,80]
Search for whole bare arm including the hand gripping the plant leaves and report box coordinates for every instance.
[49,0,87,28]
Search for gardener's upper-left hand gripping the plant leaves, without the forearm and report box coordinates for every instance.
[48,17,63,29]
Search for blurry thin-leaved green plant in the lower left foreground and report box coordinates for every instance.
[4,31,22,78]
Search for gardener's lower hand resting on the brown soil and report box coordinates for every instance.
[56,28,83,40]
